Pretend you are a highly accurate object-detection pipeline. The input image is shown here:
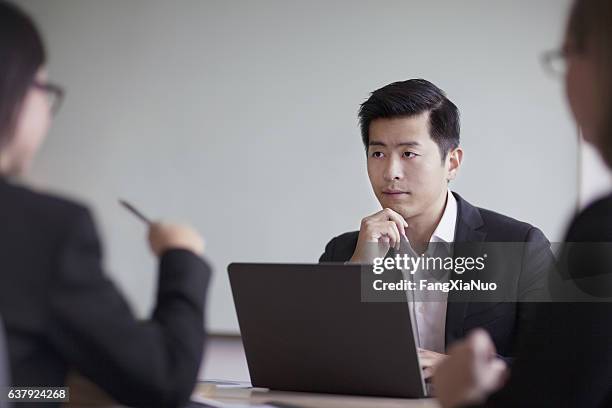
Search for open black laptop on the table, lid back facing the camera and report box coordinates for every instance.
[228,263,427,398]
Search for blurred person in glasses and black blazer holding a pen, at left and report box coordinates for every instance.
[0,1,210,407]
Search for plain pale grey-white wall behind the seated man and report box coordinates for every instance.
[16,0,577,332]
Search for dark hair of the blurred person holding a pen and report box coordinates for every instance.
[0,0,46,150]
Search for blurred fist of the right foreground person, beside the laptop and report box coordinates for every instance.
[433,329,508,408]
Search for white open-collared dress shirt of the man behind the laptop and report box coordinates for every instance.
[408,190,457,353]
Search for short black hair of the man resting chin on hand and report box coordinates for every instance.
[359,79,460,160]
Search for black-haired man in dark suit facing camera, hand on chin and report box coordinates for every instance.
[319,79,552,376]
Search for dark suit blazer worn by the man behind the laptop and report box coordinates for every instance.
[319,193,553,357]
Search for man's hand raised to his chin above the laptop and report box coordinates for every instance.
[349,208,408,263]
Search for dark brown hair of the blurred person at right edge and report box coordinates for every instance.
[567,0,612,169]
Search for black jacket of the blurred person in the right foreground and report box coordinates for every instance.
[484,195,612,408]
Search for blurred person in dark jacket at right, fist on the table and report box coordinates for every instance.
[434,0,612,408]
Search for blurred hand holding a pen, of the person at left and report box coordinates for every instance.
[149,222,204,256]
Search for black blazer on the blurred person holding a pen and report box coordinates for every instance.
[0,179,210,407]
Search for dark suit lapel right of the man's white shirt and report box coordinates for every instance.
[445,192,487,347]
